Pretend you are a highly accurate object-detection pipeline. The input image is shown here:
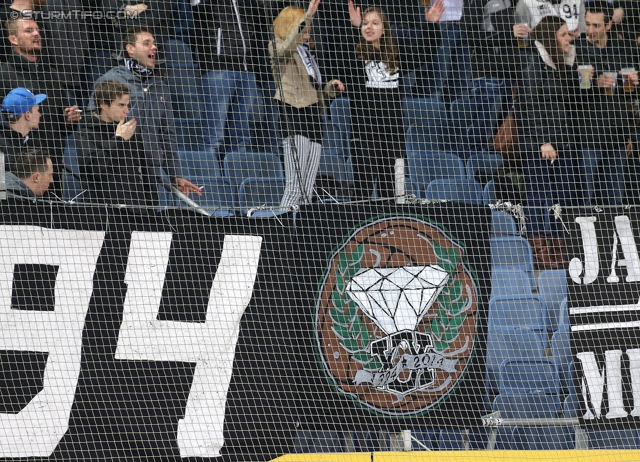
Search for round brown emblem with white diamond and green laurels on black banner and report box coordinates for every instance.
[315,217,477,415]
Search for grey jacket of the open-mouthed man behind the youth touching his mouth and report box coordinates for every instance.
[88,66,182,181]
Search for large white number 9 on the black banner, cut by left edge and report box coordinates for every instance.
[0,226,104,457]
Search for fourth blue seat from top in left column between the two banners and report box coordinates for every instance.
[489,294,546,334]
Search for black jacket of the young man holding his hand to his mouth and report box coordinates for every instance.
[75,114,158,207]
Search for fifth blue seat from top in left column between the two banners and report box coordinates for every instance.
[486,326,544,393]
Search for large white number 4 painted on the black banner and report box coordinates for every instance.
[116,232,262,457]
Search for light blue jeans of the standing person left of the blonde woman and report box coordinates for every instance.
[202,71,259,153]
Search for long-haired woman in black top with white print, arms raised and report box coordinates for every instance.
[340,0,444,199]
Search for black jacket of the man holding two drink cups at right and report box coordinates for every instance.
[575,35,638,150]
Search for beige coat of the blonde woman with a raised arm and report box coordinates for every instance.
[269,13,337,110]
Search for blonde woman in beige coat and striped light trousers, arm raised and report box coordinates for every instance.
[269,0,344,207]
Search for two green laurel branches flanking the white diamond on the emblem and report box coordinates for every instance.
[329,242,468,371]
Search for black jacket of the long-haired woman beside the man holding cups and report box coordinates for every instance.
[514,45,580,158]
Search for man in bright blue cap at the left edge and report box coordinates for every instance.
[0,87,47,170]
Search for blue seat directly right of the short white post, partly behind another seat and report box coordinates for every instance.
[407,151,465,199]
